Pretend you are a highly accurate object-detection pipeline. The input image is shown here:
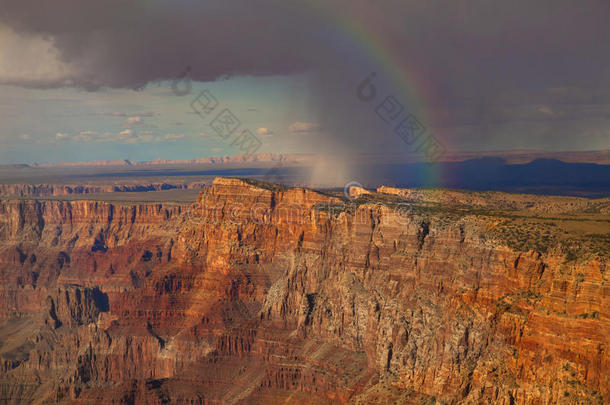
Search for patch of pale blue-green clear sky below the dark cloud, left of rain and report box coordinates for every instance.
[0,72,315,163]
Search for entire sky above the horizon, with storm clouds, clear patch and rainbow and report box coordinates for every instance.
[0,0,610,164]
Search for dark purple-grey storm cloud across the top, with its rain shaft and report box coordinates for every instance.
[0,0,610,153]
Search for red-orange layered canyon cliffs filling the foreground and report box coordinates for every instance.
[0,177,610,404]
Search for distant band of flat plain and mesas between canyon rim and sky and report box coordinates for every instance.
[0,151,610,198]
